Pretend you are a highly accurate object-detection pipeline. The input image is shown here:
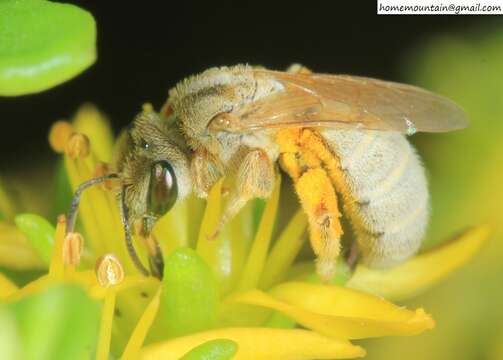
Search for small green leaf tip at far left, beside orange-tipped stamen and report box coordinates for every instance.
[14,214,56,265]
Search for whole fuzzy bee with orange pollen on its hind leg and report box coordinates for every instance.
[66,65,467,279]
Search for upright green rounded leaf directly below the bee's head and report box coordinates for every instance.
[159,248,219,337]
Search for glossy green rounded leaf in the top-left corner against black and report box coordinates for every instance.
[0,0,96,96]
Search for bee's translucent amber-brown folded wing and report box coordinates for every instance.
[227,70,468,134]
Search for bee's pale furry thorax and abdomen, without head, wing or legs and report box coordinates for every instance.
[166,66,429,267]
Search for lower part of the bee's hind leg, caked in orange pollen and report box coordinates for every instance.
[294,168,343,281]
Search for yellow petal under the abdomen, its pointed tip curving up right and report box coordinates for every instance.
[347,227,490,301]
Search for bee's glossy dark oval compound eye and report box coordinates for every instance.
[147,160,178,216]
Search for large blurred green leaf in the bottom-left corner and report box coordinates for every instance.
[7,285,99,360]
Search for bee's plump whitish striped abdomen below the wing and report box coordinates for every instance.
[322,129,429,267]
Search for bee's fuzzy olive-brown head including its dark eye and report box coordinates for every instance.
[116,112,191,221]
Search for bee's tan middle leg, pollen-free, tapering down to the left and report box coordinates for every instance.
[210,149,275,238]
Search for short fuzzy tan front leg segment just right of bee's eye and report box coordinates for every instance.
[190,148,223,198]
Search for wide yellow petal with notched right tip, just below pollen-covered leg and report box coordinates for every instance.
[228,283,434,339]
